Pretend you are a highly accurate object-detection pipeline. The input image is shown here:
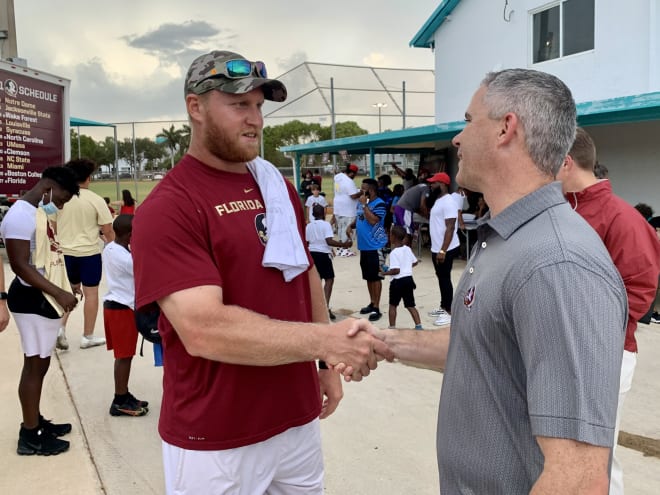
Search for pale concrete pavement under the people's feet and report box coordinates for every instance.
[0,254,660,495]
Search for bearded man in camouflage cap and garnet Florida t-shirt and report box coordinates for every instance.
[131,51,391,494]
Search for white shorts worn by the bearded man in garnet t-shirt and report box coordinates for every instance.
[163,419,323,495]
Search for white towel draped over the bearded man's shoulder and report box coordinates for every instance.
[247,157,309,282]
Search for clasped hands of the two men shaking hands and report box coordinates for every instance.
[324,319,394,382]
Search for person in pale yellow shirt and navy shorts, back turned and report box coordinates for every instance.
[57,159,115,350]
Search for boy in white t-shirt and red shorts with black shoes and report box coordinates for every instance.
[103,215,149,416]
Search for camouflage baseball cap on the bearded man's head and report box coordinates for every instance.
[185,50,286,102]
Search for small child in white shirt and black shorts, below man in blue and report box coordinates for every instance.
[383,225,423,330]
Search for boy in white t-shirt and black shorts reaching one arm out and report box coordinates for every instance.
[305,203,353,320]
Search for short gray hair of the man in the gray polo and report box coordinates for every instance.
[481,69,577,177]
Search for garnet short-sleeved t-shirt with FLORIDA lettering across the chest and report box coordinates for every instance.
[131,155,321,450]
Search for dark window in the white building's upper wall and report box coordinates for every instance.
[532,0,595,64]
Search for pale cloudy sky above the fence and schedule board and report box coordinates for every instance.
[14,0,440,138]
